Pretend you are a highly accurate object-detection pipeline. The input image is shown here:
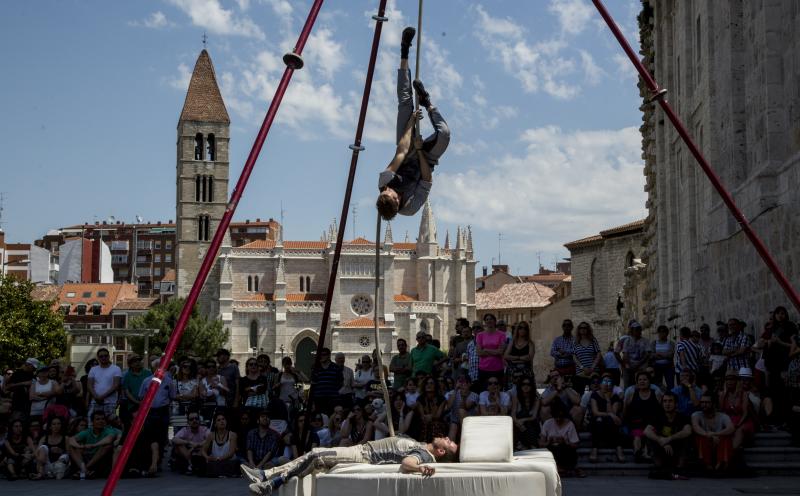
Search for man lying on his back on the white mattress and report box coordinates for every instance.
[241,437,458,495]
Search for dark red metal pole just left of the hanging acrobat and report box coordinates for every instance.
[309,0,388,376]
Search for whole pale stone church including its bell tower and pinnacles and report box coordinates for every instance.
[176,50,476,370]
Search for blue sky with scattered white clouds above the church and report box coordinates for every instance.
[0,0,646,273]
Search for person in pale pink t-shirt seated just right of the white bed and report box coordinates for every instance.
[539,398,585,477]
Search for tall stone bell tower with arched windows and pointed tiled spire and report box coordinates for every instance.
[176,49,231,302]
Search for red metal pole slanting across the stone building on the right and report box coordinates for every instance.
[592,0,800,311]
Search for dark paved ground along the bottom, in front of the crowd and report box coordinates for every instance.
[0,473,800,496]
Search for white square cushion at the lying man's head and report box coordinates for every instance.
[458,416,514,463]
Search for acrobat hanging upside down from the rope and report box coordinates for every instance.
[376,27,450,220]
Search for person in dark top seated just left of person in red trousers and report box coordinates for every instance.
[644,392,692,480]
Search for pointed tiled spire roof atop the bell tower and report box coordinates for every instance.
[181,49,231,124]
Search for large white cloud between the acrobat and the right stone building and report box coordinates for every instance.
[432,126,646,251]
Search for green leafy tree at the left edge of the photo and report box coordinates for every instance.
[0,275,67,367]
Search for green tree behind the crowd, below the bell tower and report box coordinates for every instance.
[129,298,228,358]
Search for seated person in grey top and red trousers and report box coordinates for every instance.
[692,394,736,473]
